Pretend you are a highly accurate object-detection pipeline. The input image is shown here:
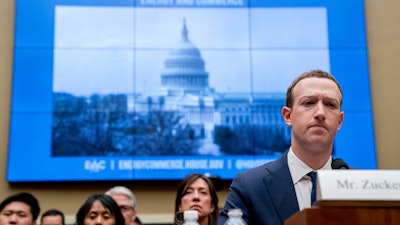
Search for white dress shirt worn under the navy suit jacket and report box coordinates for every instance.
[288,147,332,211]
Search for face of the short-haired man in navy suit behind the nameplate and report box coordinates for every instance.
[282,78,344,151]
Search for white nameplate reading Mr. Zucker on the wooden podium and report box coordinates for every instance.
[317,170,400,207]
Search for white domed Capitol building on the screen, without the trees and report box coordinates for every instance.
[126,20,290,155]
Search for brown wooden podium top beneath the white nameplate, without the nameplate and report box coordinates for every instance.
[285,206,400,225]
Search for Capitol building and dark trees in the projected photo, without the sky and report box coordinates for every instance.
[52,14,296,156]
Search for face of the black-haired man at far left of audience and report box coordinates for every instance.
[0,202,36,225]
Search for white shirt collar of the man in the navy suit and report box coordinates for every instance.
[287,147,332,184]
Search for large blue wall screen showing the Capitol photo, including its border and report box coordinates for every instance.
[7,0,376,182]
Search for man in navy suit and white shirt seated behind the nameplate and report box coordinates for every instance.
[218,70,344,225]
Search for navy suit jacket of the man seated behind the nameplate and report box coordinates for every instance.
[218,151,299,225]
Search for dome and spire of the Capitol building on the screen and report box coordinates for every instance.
[161,20,208,94]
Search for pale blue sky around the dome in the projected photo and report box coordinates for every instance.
[53,6,330,96]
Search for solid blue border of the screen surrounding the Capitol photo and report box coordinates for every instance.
[7,0,377,182]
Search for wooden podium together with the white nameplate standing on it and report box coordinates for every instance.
[284,170,400,225]
